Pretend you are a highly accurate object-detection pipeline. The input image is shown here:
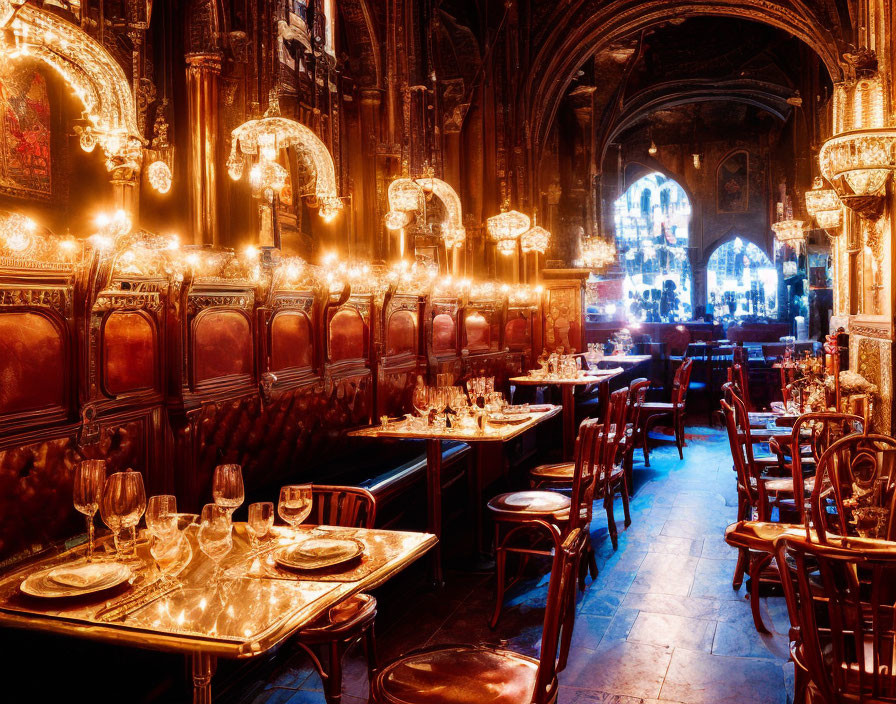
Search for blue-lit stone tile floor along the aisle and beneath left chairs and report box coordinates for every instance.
[237,427,790,704]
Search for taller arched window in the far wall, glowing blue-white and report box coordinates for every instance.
[614,173,693,322]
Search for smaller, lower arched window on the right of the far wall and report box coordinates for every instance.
[706,237,778,322]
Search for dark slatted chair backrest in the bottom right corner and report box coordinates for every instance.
[775,536,896,704]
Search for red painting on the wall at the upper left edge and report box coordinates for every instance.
[0,70,52,197]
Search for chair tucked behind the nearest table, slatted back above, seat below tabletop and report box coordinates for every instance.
[296,484,377,704]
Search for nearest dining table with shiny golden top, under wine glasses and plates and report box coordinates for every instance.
[0,522,438,704]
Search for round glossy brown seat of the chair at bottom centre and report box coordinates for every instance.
[372,645,544,704]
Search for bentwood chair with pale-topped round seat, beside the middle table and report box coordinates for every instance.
[488,418,606,628]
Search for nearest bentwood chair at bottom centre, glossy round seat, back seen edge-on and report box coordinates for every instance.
[370,521,587,704]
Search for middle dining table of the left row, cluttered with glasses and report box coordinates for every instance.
[348,404,561,586]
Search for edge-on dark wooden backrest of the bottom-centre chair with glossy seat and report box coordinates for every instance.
[532,521,587,704]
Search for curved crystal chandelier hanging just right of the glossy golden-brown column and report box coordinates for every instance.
[227,96,342,222]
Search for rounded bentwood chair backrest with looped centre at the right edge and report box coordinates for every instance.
[811,433,896,543]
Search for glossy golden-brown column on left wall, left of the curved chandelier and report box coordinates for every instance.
[186,52,221,245]
